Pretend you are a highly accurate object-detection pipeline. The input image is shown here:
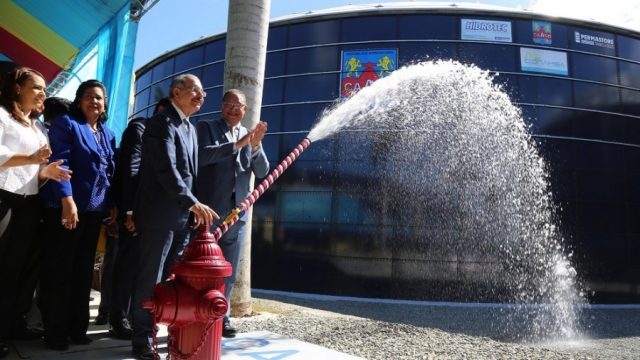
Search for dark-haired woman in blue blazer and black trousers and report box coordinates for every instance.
[40,80,117,350]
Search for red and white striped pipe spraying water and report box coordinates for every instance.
[213,139,311,242]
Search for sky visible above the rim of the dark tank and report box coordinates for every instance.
[134,0,640,70]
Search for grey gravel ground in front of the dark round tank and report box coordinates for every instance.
[233,293,640,360]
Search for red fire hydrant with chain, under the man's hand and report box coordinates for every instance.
[144,226,231,360]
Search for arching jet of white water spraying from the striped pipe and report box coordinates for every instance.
[308,61,584,339]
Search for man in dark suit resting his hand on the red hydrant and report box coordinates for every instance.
[132,74,218,359]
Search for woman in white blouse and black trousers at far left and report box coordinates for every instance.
[0,67,71,358]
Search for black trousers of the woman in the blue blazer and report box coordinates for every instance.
[40,208,108,341]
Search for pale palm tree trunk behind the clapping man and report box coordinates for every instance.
[224,0,271,316]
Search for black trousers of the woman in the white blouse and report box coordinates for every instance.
[0,189,40,339]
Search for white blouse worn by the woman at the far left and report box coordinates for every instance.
[0,106,48,195]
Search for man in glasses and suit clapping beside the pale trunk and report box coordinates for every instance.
[197,89,269,337]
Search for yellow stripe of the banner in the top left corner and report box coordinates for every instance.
[2,1,78,68]
